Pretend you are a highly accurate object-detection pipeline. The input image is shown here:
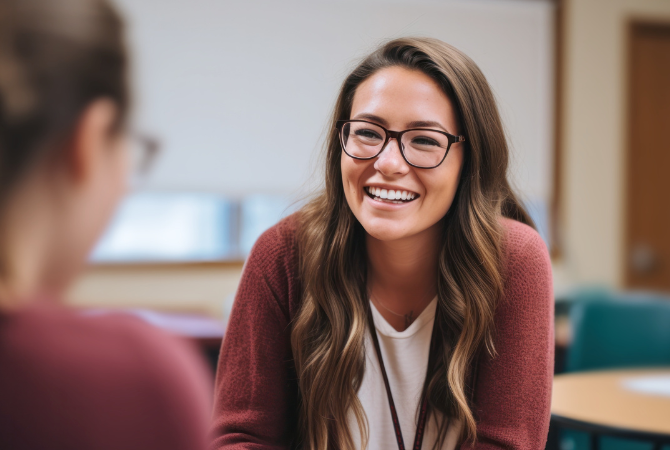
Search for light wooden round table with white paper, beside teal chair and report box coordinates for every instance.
[551,367,670,450]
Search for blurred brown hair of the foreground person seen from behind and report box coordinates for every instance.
[0,0,129,208]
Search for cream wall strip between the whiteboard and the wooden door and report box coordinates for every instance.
[562,0,670,287]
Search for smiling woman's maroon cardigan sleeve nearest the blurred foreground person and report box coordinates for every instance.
[211,224,298,449]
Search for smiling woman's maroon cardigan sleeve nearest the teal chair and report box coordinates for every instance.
[462,220,554,450]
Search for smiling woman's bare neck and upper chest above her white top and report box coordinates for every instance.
[366,222,442,329]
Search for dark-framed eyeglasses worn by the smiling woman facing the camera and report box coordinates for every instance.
[336,120,465,169]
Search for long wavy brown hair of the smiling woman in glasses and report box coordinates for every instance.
[291,38,532,450]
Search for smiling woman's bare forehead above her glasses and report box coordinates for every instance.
[351,67,457,132]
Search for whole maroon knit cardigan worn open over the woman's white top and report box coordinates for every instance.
[212,216,554,450]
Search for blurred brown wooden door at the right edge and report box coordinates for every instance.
[626,23,670,292]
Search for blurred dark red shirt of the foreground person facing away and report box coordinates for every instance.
[0,305,211,450]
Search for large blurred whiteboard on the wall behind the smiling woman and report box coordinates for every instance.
[118,0,554,204]
